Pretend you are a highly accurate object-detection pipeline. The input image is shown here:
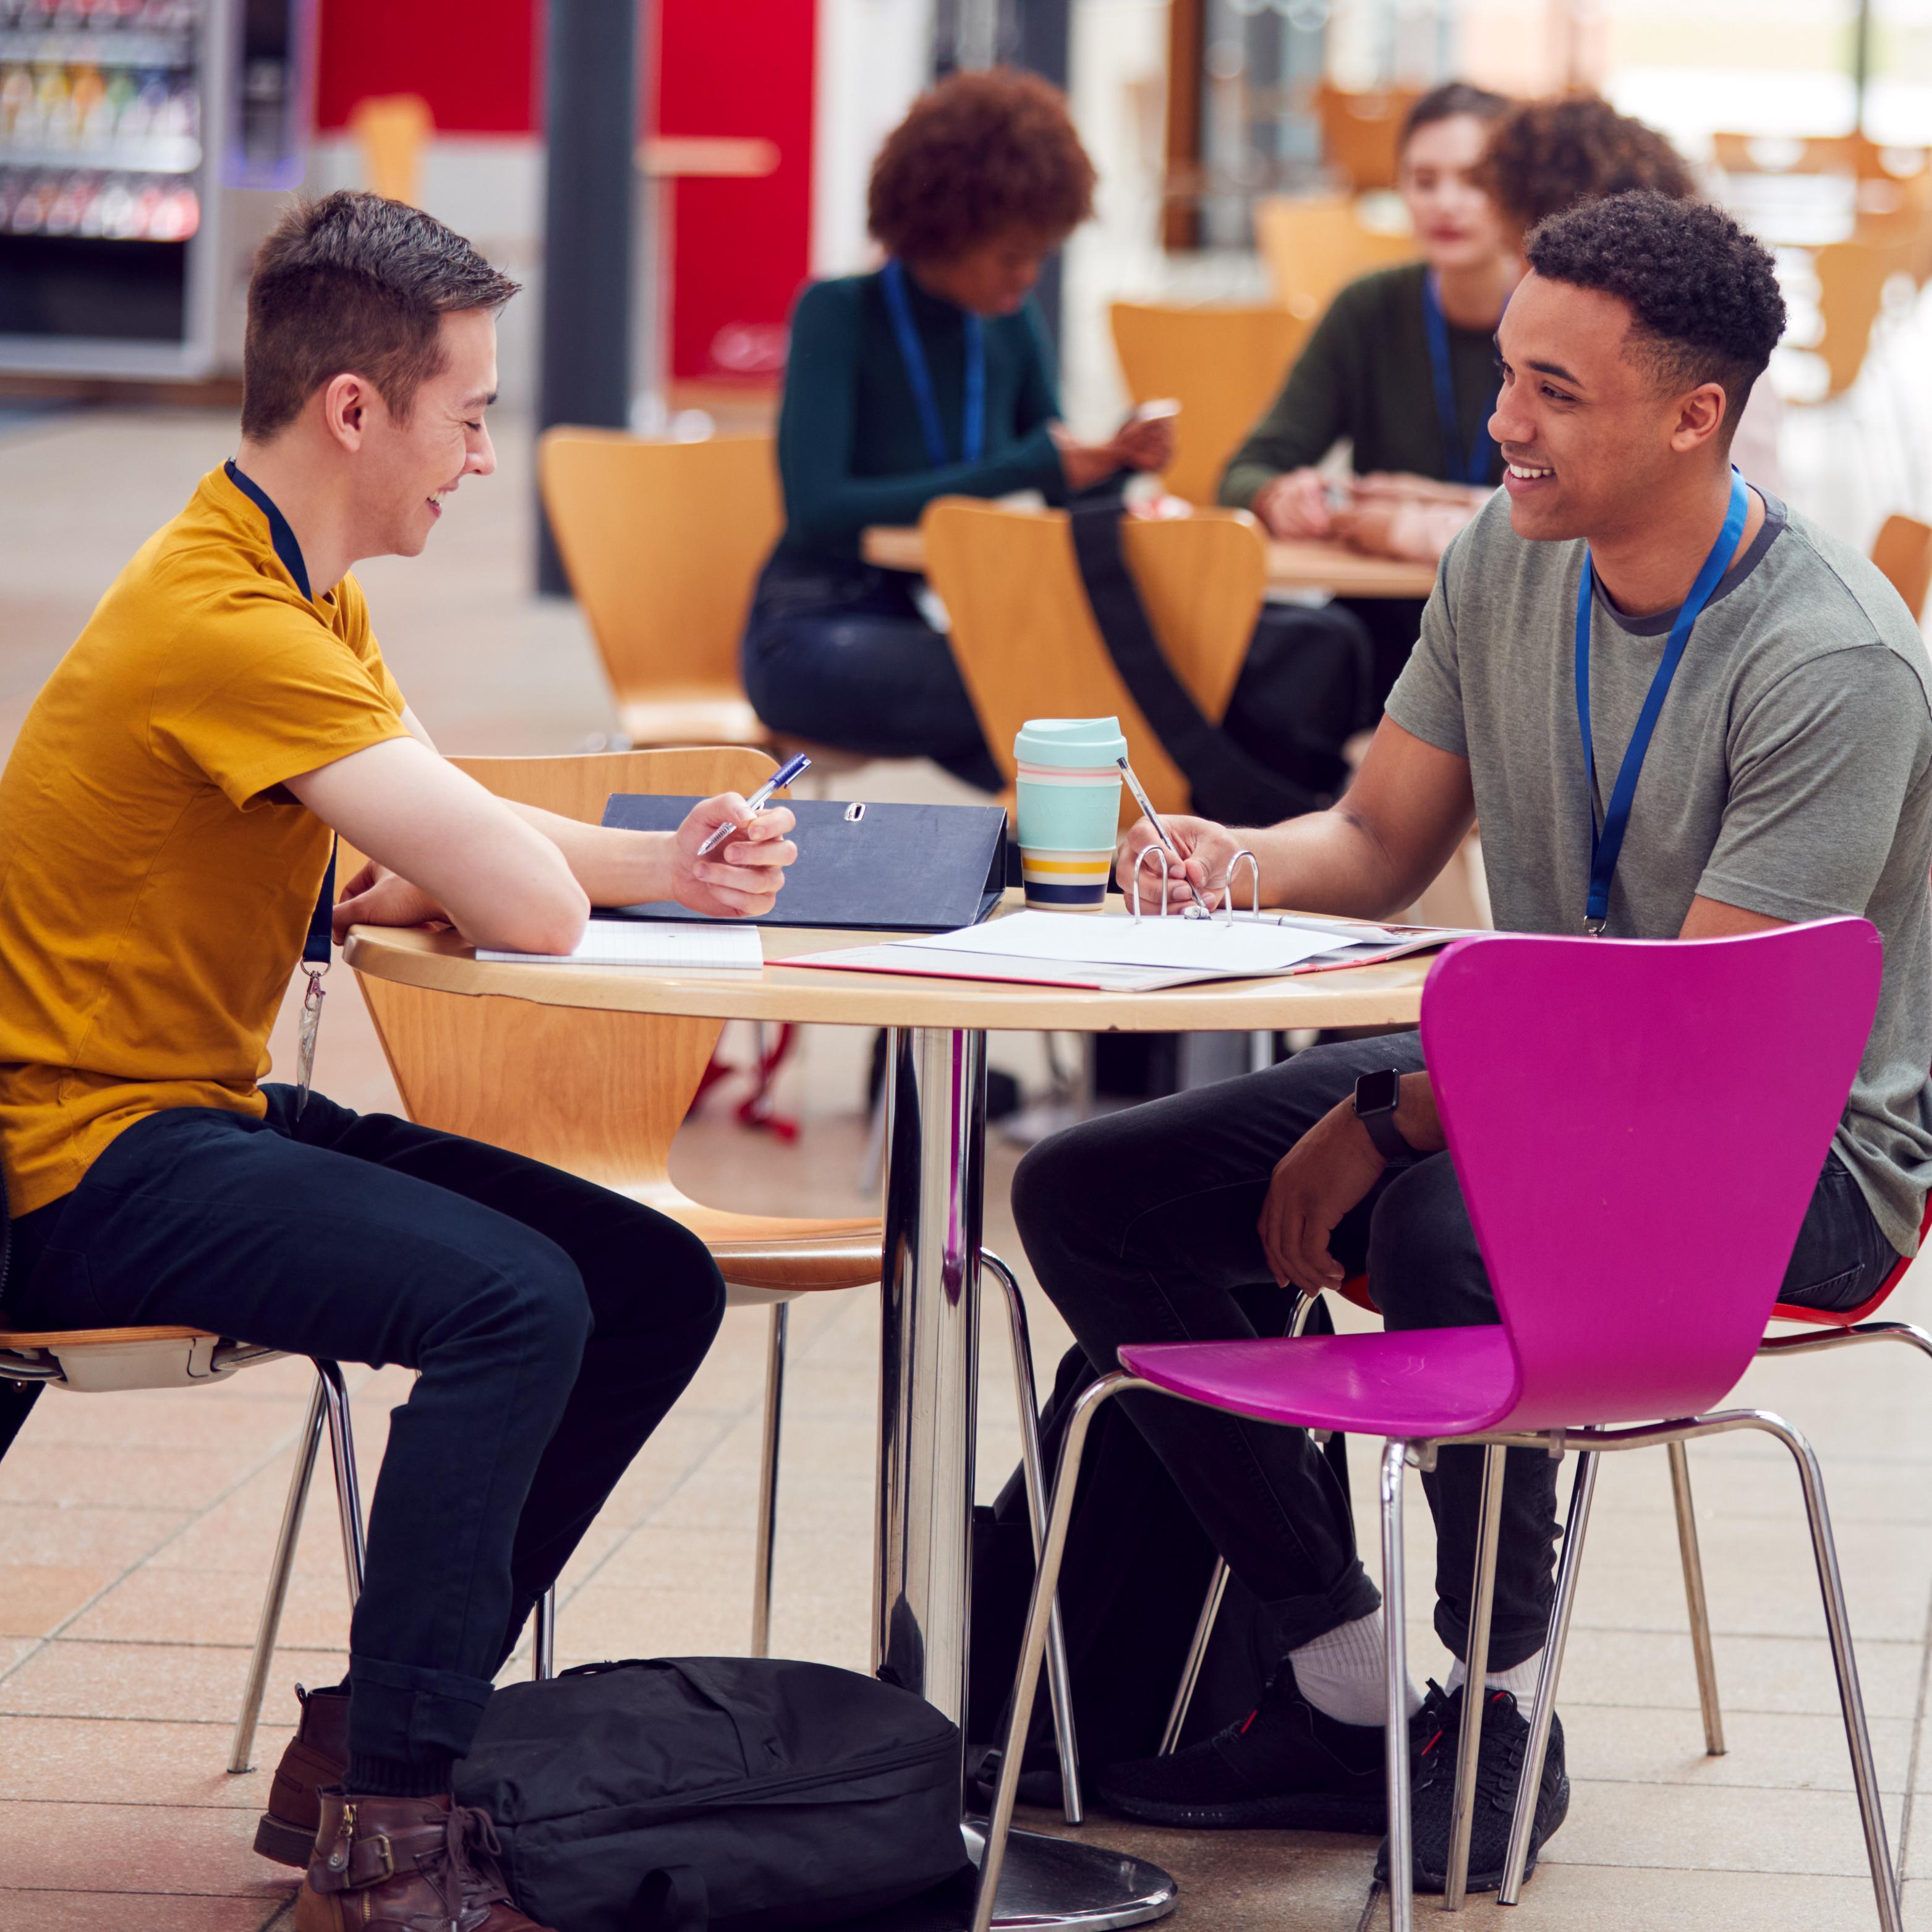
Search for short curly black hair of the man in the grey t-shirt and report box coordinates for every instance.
[1526,187,1785,428]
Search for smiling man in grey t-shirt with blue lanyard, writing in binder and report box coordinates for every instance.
[1015,194,1932,1889]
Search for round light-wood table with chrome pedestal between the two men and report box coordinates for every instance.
[344,926,1430,1932]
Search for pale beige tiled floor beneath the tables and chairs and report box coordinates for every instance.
[11,384,1932,1932]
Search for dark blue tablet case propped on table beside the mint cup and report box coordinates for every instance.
[597,792,1006,933]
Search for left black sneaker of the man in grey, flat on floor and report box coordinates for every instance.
[1097,1664,1389,1832]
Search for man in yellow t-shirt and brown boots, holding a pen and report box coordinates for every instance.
[0,194,796,1932]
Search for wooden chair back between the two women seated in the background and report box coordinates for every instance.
[1109,302,1308,504]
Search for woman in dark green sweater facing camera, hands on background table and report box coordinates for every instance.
[1221,81,1523,697]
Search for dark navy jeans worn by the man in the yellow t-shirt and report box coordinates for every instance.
[6,1086,725,1764]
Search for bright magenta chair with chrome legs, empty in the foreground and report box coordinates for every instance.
[972,920,1903,1932]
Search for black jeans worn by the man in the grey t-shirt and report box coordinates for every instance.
[1013,1034,1897,1671]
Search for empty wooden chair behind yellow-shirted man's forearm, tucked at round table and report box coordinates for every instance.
[357,746,1078,1777]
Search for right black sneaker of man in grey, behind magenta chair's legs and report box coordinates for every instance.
[1376,1683,1569,1891]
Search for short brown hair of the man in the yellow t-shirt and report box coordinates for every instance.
[242,189,518,443]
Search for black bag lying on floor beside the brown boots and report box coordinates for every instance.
[456,1658,966,1932]
